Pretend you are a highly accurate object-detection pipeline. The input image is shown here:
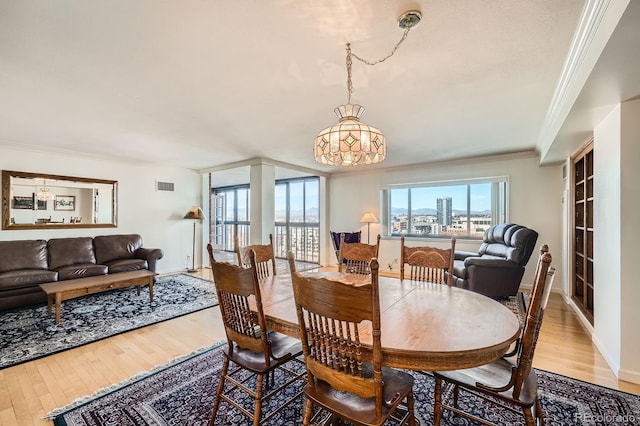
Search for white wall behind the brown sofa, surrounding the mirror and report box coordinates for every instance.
[0,147,201,273]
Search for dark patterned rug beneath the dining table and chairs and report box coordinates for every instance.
[47,346,640,426]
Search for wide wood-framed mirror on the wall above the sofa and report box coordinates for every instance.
[2,170,118,229]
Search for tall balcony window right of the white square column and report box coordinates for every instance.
[274,177,320,263]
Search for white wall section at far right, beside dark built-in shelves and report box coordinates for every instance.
[592,100,640,383]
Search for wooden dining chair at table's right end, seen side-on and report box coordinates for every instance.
[434,246,555,425]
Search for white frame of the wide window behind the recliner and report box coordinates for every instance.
[380,176,510,241]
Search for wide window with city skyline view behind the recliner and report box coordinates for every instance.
[382,177,508,238]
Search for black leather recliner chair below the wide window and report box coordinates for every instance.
[453,223,538,299]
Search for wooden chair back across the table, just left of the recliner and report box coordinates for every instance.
[400,235,456,287]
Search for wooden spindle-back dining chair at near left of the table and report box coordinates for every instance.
[207,244,306,426]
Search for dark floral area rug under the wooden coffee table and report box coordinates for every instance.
[0,274,218,369]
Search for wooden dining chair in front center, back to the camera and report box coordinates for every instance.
[287,253,415,425]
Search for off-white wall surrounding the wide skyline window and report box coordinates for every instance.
[324,154,564,288]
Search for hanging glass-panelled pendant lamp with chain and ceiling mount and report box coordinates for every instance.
[313,10,422,166]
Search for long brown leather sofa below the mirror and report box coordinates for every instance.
[0,234,163,310]
